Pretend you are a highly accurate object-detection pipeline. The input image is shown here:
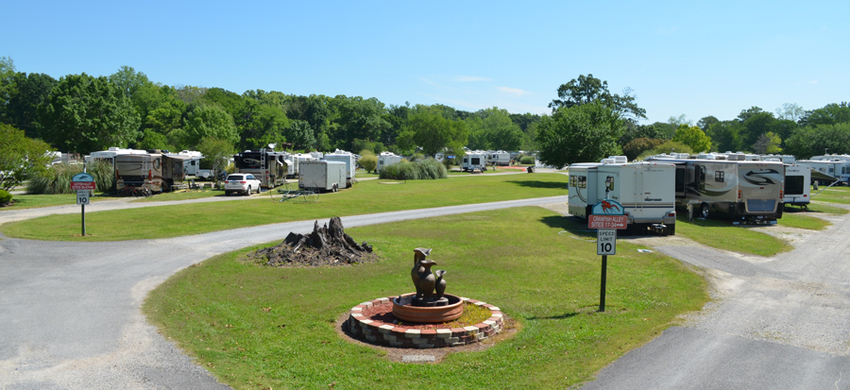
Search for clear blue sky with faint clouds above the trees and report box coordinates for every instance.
[0,0,850,123]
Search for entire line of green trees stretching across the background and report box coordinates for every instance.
[0,57,850,174]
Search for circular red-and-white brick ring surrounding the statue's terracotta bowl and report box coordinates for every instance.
[347,294,504,349]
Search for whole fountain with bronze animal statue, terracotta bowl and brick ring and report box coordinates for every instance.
[346,248,504,348]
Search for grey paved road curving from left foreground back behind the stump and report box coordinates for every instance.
[0,196,567,390]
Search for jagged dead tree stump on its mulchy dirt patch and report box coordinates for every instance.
[247,217,377,267]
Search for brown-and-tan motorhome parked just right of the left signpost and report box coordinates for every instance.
[115,150,189,193]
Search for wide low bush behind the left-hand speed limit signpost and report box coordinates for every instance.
[27,161,115,194]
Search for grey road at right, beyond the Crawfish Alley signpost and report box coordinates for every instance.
[583,206,850,390]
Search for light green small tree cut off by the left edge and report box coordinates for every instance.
[0,123,53,191]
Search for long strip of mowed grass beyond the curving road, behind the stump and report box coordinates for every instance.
[0,173,567,241]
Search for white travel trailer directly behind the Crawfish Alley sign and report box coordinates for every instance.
[568,156,676,235]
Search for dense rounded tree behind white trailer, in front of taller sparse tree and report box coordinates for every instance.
[537,102,625,167]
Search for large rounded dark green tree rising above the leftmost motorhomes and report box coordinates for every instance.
[38,73,141,153]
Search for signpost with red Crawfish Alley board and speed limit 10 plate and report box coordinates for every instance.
[587,199,629,311]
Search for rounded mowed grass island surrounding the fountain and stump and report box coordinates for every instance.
[143,207,708,389]
